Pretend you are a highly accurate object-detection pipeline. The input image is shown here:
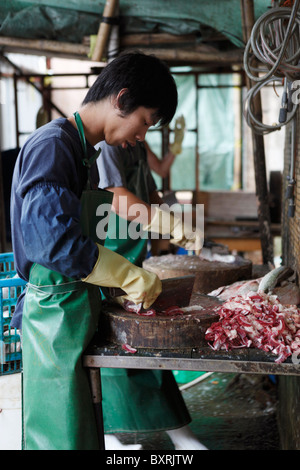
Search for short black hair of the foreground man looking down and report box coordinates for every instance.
[83,52,178,126]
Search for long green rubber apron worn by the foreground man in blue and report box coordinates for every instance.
[22,111,111,450]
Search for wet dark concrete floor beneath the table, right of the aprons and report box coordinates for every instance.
[114,373,280,450]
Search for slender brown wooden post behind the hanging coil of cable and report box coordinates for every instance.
[241,0,274,264]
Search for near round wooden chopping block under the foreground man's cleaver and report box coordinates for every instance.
[100,294,222,349]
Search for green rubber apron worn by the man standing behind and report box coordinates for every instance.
[100,144,191,434]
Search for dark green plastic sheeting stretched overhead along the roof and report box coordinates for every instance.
[0,0,271,47]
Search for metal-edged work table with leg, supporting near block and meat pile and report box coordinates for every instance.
[83,336,300,449]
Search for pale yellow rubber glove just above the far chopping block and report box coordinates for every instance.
[143,207,204,254]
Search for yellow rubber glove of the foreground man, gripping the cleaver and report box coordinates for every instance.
[82,244,162,309]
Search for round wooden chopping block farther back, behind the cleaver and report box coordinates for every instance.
[143,254,252,294]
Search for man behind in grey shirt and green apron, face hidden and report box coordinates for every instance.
[97,140,205,450]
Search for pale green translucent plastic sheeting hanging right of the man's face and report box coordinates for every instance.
[147,73,235,191]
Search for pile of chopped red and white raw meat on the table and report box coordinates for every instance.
[205,292,300,363]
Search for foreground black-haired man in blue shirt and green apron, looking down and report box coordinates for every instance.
[11,53,177,450]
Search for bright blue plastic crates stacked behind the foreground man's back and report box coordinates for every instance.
[0,253,26,375]
